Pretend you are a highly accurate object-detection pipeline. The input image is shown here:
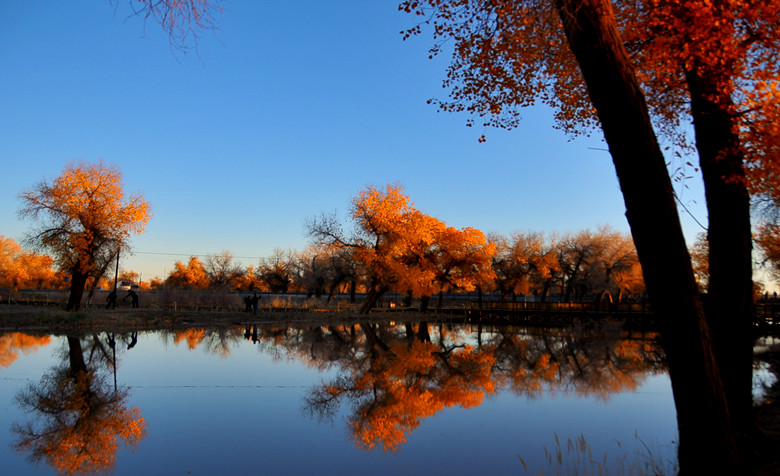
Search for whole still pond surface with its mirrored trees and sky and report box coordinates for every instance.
[0,322,677,475]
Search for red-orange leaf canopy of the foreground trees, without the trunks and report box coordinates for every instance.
[399,0,780,192]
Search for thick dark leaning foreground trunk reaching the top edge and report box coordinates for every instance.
[555,0,739,474]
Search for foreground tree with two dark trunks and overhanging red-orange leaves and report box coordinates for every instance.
[401,0,780,470]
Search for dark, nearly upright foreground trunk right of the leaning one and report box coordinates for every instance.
[686,70,753,442]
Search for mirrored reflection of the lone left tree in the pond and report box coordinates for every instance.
[11,335,146,474]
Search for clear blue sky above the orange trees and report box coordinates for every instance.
[0,0,706,279]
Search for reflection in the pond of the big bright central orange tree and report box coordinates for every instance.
[305,323,495,451]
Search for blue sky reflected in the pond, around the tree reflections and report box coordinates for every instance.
[0,334,676,475]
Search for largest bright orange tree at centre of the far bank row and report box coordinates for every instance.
[307,184,495,312]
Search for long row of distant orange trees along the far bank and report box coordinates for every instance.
[0,185,780,312]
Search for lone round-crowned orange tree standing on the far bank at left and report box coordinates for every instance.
[19,161,151,311]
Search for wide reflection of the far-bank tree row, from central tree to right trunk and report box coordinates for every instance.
[290,322,663,451]
